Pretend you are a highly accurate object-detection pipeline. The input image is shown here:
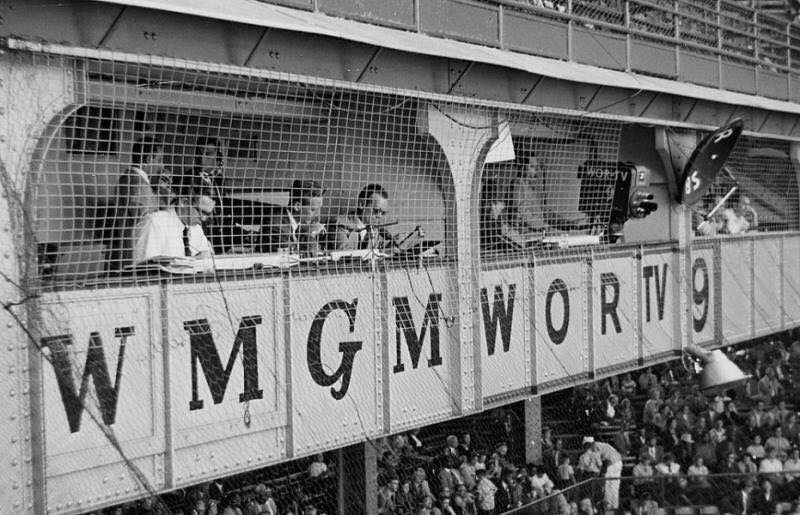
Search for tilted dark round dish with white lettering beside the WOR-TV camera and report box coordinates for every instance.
[679,118,744,206]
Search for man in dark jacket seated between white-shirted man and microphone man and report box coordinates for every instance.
[261,179,325,255]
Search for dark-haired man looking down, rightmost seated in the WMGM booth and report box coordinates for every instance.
[335,184,425,254]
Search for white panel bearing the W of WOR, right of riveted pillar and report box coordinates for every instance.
[479,267,531,397]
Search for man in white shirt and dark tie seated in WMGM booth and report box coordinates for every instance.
[133,186,216,263]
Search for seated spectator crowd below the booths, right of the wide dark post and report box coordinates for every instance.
[377,331,800,515]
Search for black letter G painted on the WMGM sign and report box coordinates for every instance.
[306,299,362,401]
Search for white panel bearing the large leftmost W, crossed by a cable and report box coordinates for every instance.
[40,288,164,511]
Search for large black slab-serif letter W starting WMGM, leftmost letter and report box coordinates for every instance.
[42,327,134,433]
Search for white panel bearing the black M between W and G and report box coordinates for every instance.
[167,279,286,485]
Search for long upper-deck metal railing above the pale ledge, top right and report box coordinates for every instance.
[262,0,800,97]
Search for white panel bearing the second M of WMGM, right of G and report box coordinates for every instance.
[384,269,460,432]
